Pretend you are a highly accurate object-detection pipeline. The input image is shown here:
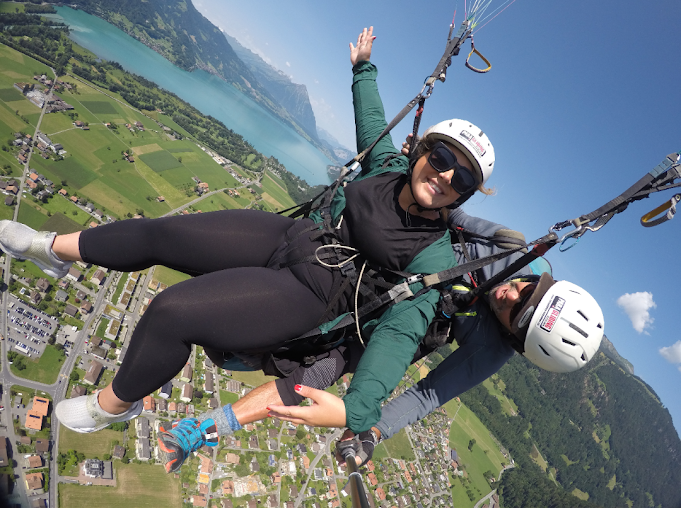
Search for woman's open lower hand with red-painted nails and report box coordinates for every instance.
[267,385,346,427]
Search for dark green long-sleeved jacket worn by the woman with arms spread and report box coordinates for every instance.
[314,62,457,433]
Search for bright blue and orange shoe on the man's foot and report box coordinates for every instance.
[157,418,218,473]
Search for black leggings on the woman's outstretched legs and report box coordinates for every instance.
[79,210,332,402]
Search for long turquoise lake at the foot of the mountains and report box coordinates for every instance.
[55,7,333,185]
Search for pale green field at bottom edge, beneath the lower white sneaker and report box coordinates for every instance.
[59,461,182,508]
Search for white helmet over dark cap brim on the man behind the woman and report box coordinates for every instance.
[511,273,604,372]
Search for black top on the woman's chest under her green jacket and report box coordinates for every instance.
[340,172,447,270]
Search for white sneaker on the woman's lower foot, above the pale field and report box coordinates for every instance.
[55,391,142,434]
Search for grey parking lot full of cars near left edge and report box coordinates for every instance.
[7,295,58,358]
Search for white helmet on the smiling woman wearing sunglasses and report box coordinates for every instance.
[423,118,494,185]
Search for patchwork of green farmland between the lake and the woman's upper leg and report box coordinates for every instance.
[0,46,266,222]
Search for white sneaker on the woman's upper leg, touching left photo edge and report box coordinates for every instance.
[0,220,73,279]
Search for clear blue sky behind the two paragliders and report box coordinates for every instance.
[194,0,681,430]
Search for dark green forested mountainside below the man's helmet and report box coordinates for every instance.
[461,354,681,508]
